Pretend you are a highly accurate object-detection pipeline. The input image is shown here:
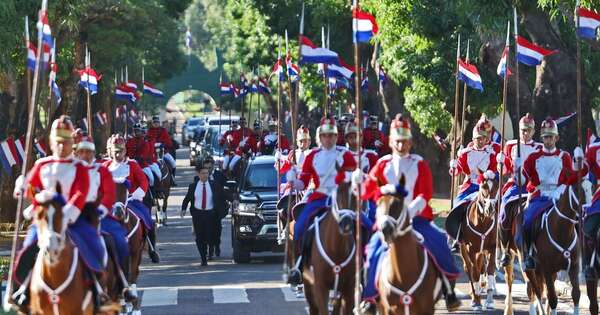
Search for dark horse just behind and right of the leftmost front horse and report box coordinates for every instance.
[113,183,146,314]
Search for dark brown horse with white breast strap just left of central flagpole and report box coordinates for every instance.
[303,183,360,315]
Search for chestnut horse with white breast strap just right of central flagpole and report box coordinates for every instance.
[377,176,443,315]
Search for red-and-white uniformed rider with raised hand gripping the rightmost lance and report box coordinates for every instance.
[522,118,588,269]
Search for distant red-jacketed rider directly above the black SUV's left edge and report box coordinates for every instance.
[219,117,256,171]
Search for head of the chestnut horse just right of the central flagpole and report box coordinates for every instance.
[377,175,411,242]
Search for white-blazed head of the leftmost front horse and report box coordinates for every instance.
[34,184,68,265]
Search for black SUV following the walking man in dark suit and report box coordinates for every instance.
[231,156,283,263]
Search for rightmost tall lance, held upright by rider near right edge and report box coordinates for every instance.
[575,0,585,266]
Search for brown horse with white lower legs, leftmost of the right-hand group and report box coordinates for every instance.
[460,173,499,311]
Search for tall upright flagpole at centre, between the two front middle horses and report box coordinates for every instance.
[352,0,363,307]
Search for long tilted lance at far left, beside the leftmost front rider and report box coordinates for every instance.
[2,0,48,312]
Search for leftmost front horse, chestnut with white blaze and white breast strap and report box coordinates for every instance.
[30,185,94,315]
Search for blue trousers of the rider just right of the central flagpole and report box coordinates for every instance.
[363,217,460,301]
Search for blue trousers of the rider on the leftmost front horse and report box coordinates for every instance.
[21,216,108,272]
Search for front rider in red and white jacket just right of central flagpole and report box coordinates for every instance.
[361,115,460,312]
